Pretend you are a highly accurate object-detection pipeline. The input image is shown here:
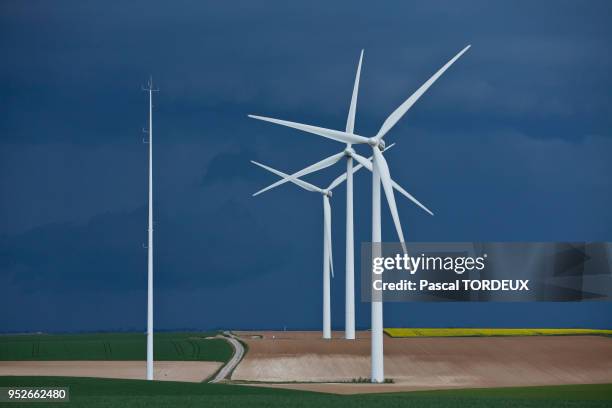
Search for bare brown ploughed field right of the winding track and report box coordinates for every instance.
[232,332,612,393]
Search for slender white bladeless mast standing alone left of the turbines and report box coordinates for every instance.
[143,77,158,380]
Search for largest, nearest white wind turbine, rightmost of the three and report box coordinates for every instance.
[249,45,470,383]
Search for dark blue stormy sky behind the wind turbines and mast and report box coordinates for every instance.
[0,1,612,331]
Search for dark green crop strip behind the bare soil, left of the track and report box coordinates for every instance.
[0,332,233,362]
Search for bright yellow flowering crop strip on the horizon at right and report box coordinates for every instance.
[385,328,612,337]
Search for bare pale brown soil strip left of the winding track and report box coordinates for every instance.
[0,361,222,382]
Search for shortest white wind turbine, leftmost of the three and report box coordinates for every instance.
[251,144,411,339]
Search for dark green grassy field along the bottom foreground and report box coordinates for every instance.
[0,377,612,408]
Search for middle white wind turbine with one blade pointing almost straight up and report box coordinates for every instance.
[249,50,433,340]
